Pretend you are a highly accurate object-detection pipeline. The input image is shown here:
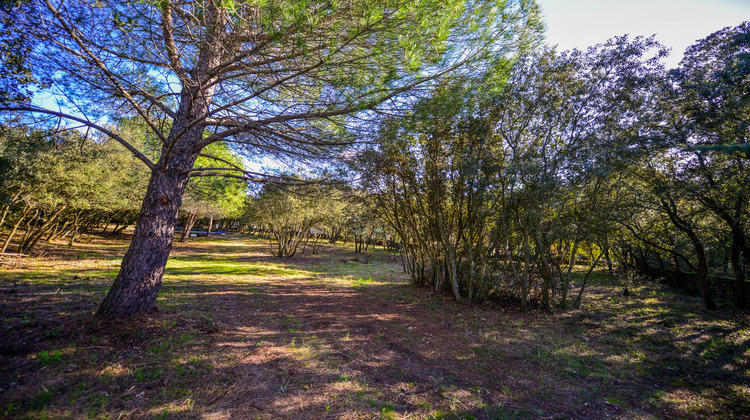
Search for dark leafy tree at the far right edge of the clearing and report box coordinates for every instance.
[621,22,750,307]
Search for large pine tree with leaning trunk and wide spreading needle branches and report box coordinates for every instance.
[0,0,541,317]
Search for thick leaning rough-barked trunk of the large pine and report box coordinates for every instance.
[96,2,233,318]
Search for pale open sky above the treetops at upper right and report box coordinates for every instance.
[539,0,750,68]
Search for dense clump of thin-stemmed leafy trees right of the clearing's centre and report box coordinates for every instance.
[355,37,663,307]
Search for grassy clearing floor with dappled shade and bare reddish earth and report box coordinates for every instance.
[0,237,750,419]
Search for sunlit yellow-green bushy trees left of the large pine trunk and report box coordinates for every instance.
[0,121,153,252]
